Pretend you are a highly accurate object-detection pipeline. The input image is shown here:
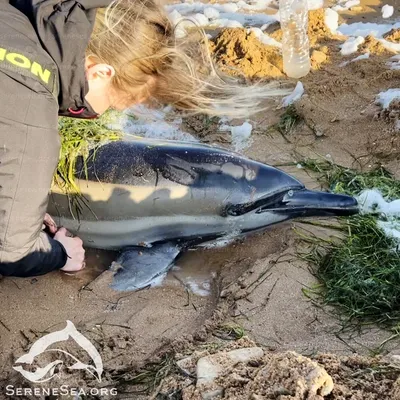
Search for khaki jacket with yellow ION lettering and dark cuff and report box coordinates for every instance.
[0,0,110,276]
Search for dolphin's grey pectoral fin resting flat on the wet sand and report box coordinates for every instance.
[111,243,180,291]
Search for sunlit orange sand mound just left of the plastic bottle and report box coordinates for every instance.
[211,28,283,78]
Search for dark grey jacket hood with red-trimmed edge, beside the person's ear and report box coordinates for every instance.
[10,0,112,118]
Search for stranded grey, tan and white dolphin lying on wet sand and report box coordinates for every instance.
[48,138,358,290]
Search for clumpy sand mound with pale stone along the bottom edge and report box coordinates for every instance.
[157,338,400,400]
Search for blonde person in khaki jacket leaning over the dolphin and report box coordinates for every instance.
[0,0,282,276]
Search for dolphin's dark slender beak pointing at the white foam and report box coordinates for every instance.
[258,189,359,216]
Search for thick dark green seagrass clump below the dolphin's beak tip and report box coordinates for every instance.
[303,215,400,327]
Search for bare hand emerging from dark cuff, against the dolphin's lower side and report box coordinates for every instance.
[54,228,85,272]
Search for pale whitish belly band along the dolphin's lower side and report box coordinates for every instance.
[50,205,287,249]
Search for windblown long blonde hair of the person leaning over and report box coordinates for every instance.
[87,0,285,118]
